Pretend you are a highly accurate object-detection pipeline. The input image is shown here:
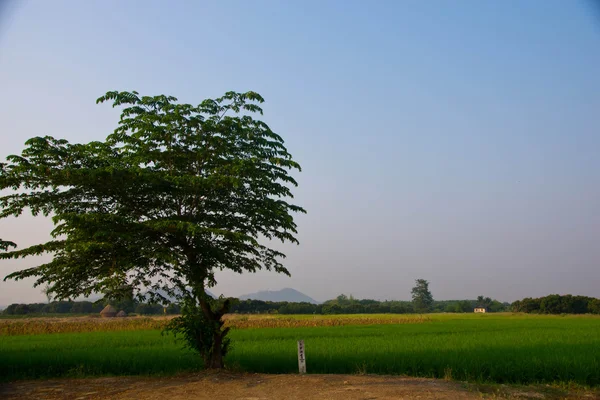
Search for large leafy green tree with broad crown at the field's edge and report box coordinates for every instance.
[0,91,304,368]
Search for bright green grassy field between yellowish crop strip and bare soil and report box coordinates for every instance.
[0,315,600,386]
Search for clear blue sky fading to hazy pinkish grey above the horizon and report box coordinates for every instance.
[0,0,600,305]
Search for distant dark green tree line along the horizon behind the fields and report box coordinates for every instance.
[3,288,600,315]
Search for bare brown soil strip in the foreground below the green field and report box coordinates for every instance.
[0,372,600,400]
